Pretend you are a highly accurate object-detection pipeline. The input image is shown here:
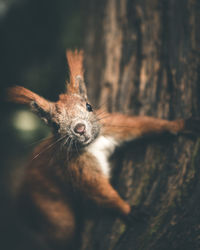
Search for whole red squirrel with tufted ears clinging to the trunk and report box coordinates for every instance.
[9,50,200,250]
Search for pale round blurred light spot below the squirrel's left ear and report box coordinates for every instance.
[13,110,39,132]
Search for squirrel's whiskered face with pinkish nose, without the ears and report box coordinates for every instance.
[50,94,100,147]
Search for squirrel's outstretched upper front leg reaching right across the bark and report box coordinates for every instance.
[100,113,200,142]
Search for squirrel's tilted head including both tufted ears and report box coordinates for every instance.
[8,50,100,146]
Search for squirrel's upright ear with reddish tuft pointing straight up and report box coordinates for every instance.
[66,50,87,99]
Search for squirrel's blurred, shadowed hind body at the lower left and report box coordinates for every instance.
[18,138,77,249]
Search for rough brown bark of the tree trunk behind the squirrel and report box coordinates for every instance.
[81,0,200,250]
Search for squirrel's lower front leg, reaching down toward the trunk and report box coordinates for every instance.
[72,156,131,218]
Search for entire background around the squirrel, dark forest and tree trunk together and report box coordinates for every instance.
[0,0,200,250]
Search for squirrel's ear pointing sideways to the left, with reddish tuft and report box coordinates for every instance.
[8,86,54,123]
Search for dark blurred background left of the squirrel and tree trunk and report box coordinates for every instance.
[0,0,84,249]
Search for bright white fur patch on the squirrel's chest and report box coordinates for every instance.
[87,136,118,177]
